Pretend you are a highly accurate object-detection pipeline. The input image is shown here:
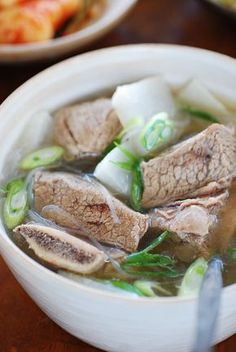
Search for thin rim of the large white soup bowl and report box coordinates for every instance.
[0,43,236,304]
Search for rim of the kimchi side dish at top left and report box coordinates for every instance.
[0,0,138,55]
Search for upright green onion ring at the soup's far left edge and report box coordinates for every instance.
[3,179,28,230]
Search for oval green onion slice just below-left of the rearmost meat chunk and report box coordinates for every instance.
[20,146,64,170]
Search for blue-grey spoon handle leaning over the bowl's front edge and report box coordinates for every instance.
[193,256,223,352]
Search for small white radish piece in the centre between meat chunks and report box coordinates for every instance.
[94,145,132,197]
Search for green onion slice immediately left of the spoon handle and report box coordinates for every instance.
[178,258,208,296]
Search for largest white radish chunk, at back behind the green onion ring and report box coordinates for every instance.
[112,76,175,126]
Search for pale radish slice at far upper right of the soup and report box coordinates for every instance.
[177,79,229,116]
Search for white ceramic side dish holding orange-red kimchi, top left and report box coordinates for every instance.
[0,0,137,63]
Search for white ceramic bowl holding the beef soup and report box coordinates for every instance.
[0,45,236,352]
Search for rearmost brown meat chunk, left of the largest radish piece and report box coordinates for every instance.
[54,98,122,159]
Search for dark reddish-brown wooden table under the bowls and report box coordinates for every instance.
[0,0,236,352]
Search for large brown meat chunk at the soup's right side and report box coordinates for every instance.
[141,124,236,208]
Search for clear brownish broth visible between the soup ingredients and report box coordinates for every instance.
[3,80,236,296]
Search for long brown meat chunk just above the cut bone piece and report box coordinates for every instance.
[34,171,148,252]
